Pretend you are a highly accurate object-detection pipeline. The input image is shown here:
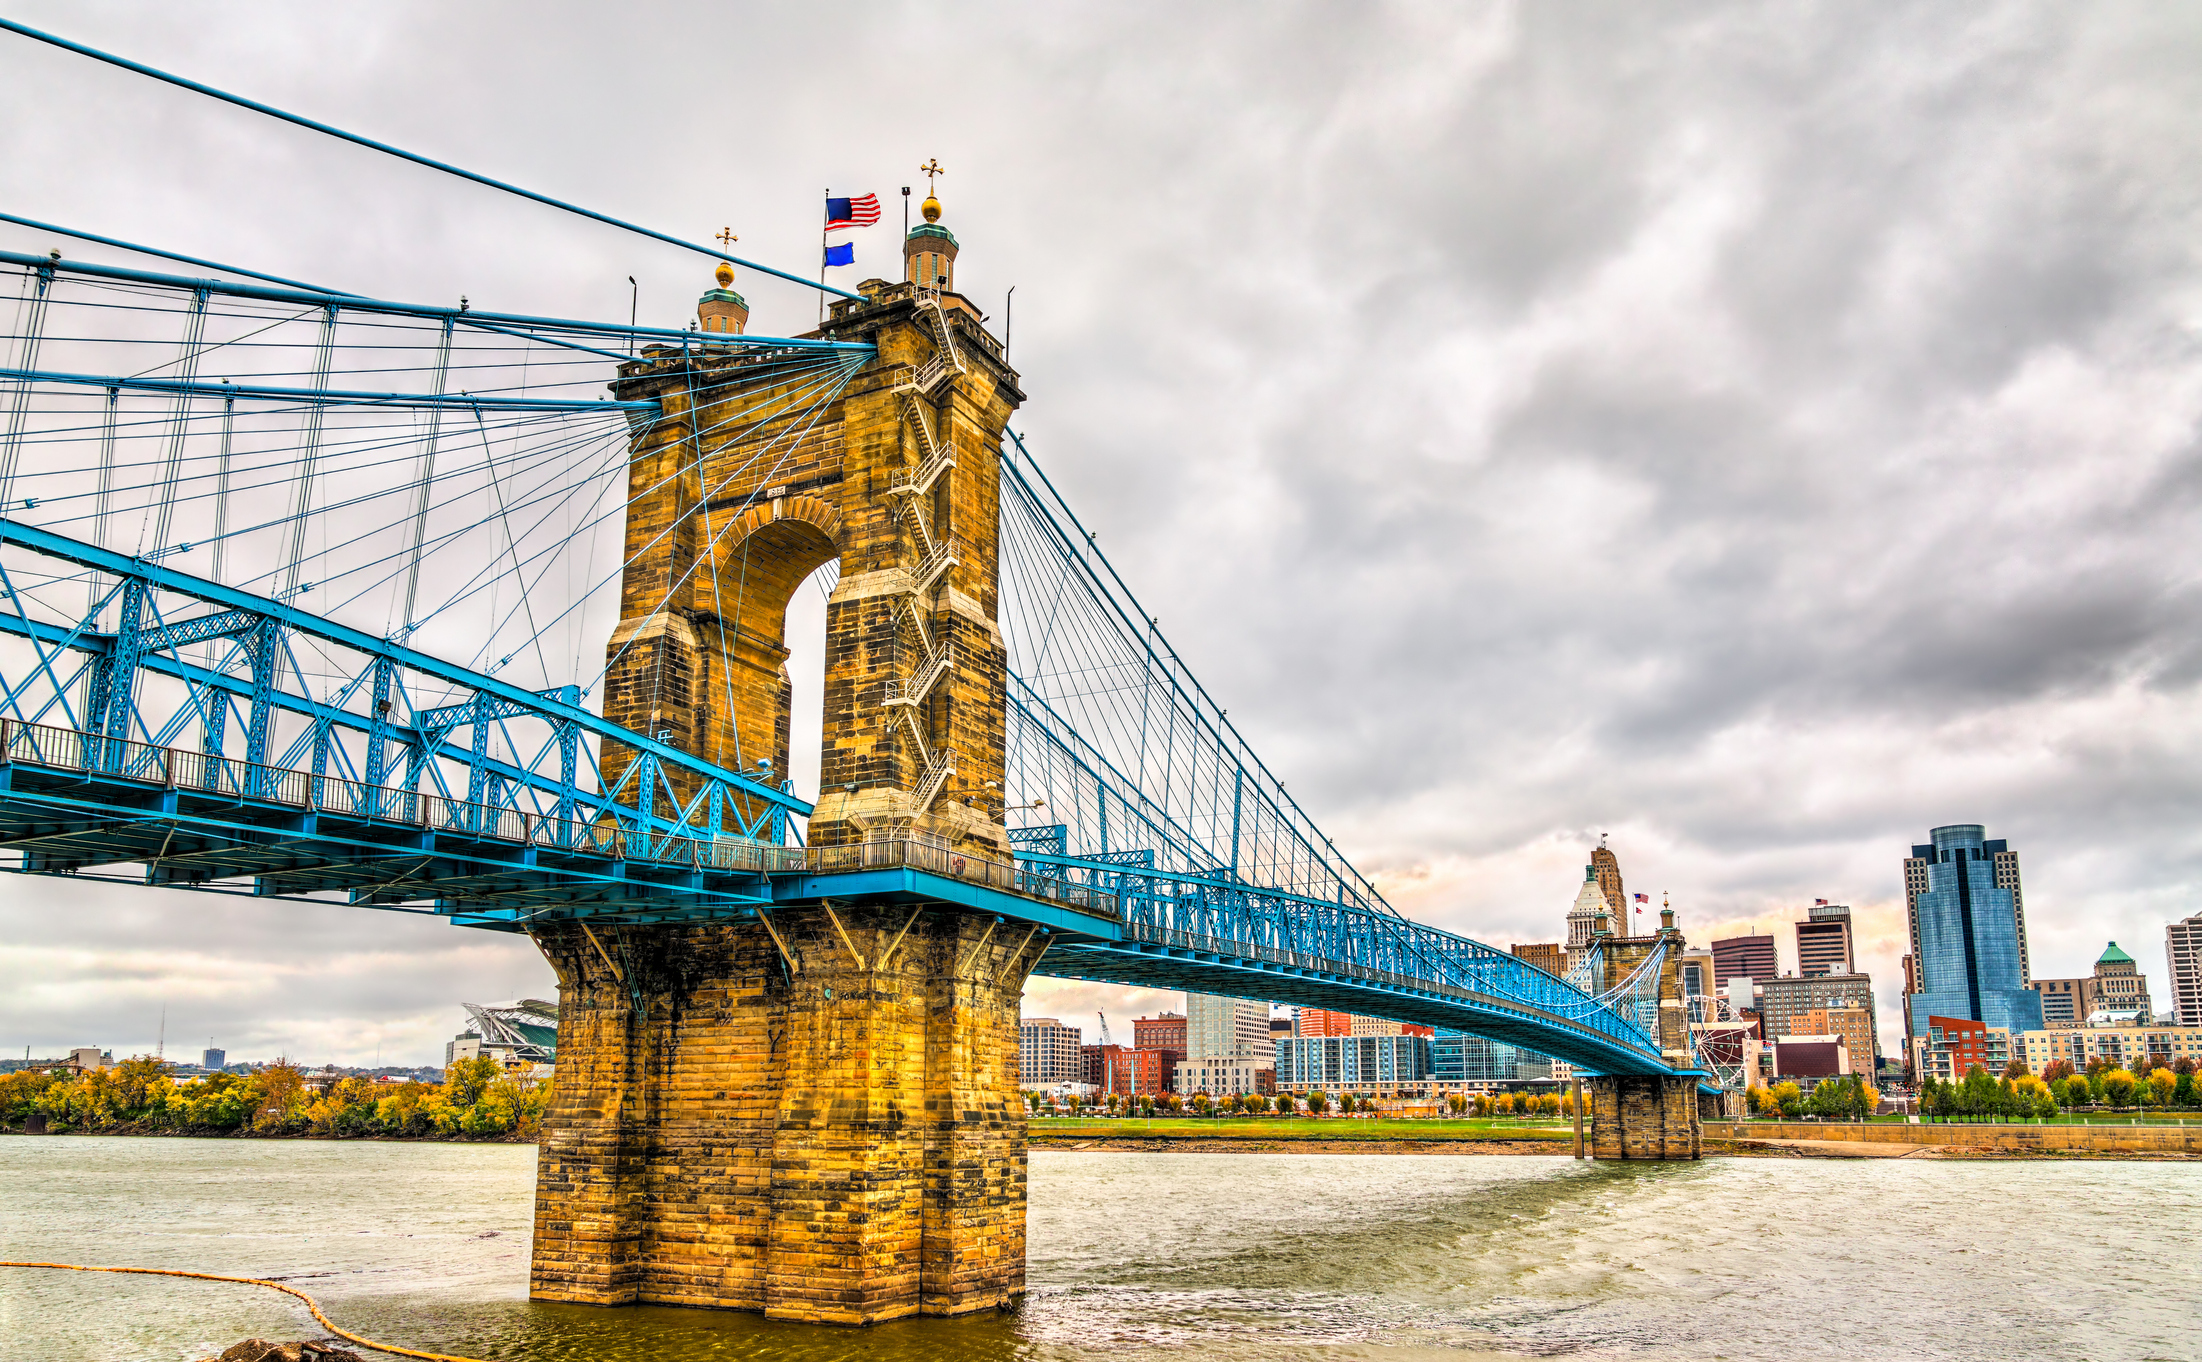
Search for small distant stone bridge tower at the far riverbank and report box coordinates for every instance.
[1590,909,1704,1160]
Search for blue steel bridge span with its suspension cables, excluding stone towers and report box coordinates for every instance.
[0,24,1704,1091]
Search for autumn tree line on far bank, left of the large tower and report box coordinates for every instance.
[0,1056,551,1140]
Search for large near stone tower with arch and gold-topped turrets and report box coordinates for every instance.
[531,198,1044,1325]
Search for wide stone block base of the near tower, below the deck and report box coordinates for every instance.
[531,904,1037,1325]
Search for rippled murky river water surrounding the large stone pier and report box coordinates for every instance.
[0,1138,2202,1362]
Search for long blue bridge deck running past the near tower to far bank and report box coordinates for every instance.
[0,722,1674,1074]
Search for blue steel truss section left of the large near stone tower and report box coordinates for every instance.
[0,517,810,913]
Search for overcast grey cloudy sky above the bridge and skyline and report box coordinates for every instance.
[0,2,2202,1063]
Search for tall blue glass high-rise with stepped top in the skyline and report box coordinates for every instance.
[1905,823,2041,1034]
